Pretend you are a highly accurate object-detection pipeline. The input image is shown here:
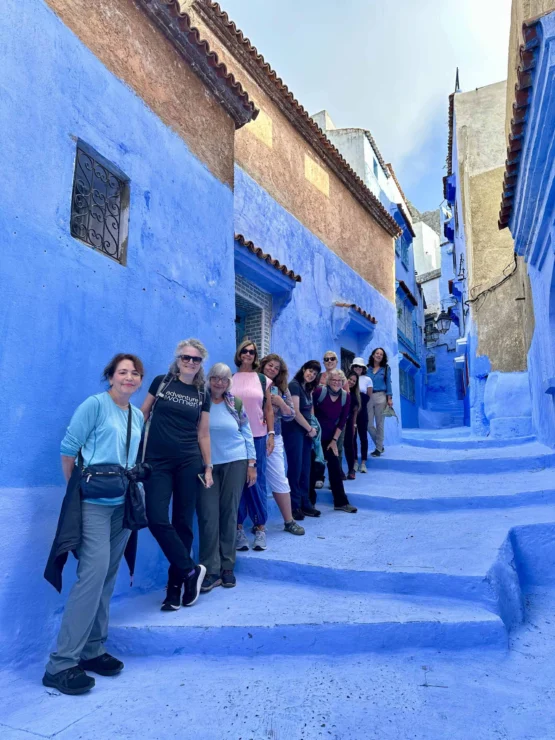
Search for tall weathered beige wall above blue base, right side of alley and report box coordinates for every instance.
[455,82,531,372]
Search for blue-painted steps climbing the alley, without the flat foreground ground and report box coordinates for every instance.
[110,429,555,656]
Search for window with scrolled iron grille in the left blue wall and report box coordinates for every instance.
[71,142,129,265]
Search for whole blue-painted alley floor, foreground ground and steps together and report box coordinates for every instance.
[0,430,555,740]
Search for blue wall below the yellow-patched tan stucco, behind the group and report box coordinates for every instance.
[235,167,399,398]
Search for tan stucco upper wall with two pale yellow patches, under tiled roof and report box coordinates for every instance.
[182,0,395,302]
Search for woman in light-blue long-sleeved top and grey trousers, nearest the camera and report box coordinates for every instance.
[42,353,144,694]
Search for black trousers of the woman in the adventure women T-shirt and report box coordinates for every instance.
[144,457,203,583]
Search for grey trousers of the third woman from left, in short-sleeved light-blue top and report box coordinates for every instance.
[197,460,247,576]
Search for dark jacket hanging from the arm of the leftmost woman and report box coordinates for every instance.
[44,465,137,591]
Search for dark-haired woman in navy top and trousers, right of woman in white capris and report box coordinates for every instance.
[281,360,322,521]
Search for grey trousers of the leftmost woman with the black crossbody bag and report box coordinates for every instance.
[46,502,131,674]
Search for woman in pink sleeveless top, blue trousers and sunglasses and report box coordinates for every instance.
[231,339,274,550]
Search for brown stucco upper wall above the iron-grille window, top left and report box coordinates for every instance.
[46,0,235,186]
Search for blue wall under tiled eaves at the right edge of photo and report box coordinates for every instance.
[509,13,555,447]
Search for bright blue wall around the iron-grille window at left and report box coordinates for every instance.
[0,0,235,660]
